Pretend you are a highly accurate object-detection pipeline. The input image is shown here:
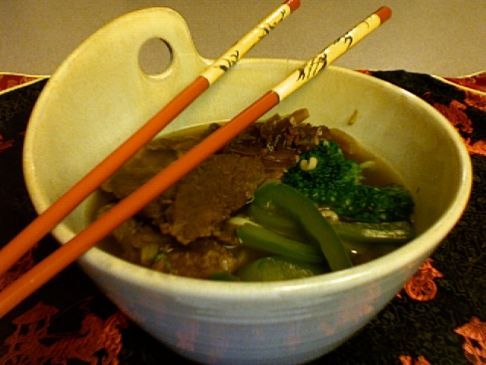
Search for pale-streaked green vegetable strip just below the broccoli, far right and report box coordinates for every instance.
[333,221,414,243]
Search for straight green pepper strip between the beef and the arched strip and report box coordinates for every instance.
[236,223,324,263]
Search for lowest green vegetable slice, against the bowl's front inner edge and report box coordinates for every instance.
[237,257,325,281]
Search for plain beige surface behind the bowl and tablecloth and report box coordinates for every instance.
[0,0,486,76]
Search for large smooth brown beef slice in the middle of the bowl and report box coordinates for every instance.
[161,154,265,244]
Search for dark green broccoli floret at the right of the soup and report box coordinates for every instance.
[283,141,414,223]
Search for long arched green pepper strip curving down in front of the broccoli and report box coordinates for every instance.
[252,182,352,271]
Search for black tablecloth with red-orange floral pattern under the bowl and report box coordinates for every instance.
[0,71,486,365]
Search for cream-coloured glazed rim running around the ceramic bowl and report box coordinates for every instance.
[23,64,472,303]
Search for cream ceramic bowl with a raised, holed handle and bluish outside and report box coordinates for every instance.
[24,8,471,364]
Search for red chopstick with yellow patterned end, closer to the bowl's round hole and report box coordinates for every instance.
[0,0,300,275]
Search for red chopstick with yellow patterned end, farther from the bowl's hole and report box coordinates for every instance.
[0,7,391,317]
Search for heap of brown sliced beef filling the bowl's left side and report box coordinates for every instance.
[98,110,330,278]
